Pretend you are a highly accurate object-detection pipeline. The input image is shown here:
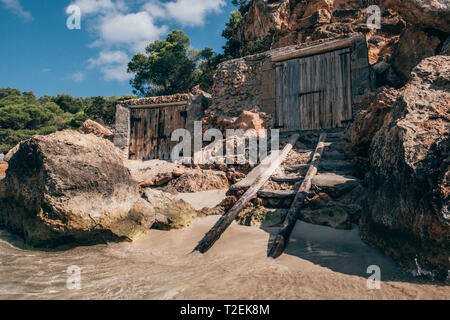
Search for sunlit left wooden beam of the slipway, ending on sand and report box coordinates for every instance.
[194,134,300,253]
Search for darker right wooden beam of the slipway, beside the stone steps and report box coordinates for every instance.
[268,133,327,259]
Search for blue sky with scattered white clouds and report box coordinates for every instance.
[0,0,235,97]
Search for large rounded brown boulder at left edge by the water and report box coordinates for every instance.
[0,131,155,247]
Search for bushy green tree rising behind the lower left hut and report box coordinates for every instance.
[128,30,197,96]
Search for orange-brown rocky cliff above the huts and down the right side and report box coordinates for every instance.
[235,0,450,277]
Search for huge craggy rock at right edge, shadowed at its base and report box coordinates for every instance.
[355,56,450,276]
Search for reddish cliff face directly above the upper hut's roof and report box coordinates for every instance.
[235,0,406,63]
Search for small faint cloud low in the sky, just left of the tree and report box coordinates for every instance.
[88,51,132,82]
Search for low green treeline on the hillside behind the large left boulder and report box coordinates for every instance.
[0,88,123,152]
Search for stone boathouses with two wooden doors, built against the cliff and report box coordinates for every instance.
[115,35,374,160]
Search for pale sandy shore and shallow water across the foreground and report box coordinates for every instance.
[0,217,450,300]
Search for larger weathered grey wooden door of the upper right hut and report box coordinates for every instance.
[275,48,352,131]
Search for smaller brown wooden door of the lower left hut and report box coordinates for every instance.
[129,105,187,160]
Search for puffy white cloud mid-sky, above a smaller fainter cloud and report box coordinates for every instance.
[99,12,167,51]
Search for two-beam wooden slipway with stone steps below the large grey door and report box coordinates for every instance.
[194,130,359,258]
